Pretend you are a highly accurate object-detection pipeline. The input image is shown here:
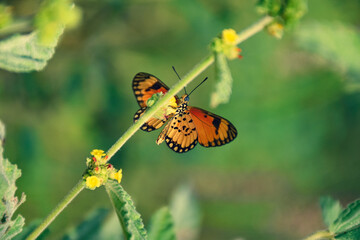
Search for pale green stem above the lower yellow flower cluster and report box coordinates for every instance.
[107,16,273,160]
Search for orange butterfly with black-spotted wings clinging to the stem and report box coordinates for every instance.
[132,72,237,153]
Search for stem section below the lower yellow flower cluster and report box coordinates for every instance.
[26,179,85,240]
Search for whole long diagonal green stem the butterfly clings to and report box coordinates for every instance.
[27,17,273,240]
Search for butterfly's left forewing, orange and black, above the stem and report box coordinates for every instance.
[132,72,169,108]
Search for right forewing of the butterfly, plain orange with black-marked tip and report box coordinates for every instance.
[189,107,237,147]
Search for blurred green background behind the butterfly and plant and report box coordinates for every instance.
[0,0,360,240]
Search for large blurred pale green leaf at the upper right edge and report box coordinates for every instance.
[295,22,360,90]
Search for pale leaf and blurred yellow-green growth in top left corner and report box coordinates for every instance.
[0,0,81,72]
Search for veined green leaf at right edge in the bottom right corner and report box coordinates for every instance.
[329,199,360,235]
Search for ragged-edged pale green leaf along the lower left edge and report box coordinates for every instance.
[0,121,25,239]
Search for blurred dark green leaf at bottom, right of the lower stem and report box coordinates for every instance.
[63,208,109,240]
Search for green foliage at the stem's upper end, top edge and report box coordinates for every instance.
[257,0,307,27]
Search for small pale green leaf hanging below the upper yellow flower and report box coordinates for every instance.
[210,52,233,108]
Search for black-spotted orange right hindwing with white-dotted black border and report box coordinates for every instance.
[157,111,198,153]
